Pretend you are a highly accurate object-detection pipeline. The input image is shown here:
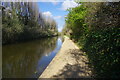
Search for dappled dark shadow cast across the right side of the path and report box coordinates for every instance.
[53,49,91,78]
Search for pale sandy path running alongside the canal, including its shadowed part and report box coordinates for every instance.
[39,37,92,78]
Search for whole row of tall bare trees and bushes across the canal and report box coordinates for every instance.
[0,2,58,44]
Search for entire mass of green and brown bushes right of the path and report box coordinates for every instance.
[63,2,120,78]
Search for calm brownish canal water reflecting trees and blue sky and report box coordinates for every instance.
[2,37,62,78]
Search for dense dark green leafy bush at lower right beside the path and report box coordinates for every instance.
[83,28,120,78]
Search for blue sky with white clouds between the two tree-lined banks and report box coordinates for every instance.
[38,0,78,32]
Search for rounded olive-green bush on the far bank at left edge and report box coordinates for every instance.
[2,7,23,43]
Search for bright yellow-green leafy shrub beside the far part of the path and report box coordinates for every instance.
[66,5,86,39]
